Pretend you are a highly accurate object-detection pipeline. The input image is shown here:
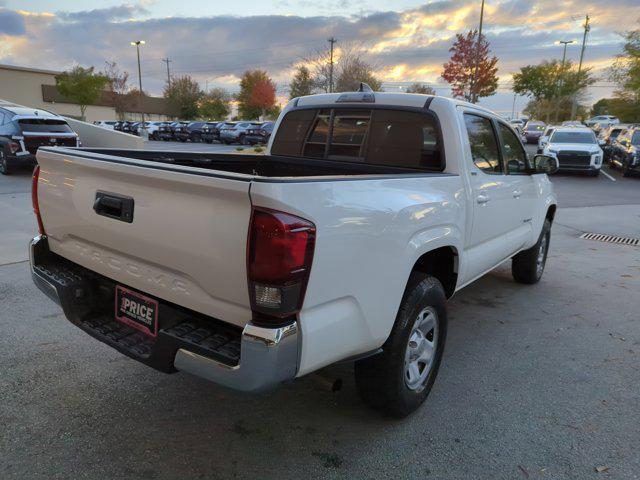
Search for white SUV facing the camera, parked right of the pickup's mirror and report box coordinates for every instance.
[543,127,603,176]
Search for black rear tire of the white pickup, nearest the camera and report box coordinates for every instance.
[355,272,447,418]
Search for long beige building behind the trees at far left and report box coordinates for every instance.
[0,64,178,122]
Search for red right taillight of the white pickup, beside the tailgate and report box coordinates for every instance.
[247,208,316,323]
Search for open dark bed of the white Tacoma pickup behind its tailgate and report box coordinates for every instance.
[53,148,445,181]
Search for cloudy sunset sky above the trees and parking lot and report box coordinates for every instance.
[0,0,640,112]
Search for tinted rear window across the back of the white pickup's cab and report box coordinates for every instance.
[271,109,444,171]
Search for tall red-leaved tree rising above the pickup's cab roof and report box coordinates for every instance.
[442,30,498,103]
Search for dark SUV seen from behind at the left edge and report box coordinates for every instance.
[0,104,80,175]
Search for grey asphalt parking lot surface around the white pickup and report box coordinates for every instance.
[0,142,640,480]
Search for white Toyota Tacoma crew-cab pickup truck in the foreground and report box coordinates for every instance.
[30,91,557,417]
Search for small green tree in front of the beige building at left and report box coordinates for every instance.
[56,65,108,120]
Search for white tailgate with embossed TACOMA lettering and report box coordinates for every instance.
[37,149,251,326]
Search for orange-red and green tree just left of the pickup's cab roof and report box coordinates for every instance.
[236,70,276,119]
